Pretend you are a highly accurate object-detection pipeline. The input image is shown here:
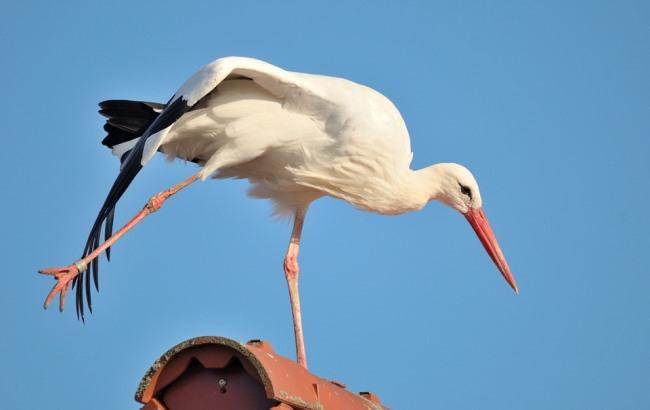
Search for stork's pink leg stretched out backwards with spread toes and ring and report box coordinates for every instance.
[38,175,199,311]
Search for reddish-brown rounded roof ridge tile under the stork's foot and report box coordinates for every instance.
[135,336,386,410]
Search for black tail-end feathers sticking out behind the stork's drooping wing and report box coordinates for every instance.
[99,100,165,160]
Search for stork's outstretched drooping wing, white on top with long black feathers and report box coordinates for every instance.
[74,57,324,319]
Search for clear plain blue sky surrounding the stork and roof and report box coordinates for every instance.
[0,1,650,410]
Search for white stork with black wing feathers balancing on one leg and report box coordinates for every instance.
[39,57,519,367]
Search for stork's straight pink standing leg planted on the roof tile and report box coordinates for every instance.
[284,209,307,368]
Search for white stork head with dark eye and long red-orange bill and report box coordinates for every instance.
[431,164,519,293]
